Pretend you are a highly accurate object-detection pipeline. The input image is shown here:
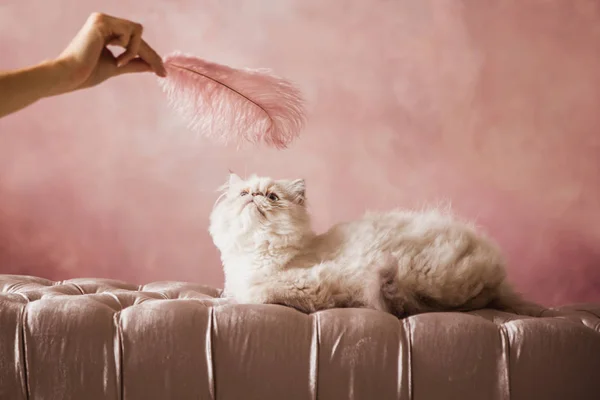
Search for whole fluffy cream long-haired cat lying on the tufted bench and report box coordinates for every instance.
[209,173,520,317]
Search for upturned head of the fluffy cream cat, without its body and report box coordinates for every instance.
[209,173,311,254]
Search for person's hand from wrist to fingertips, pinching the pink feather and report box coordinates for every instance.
[55,13,166,92]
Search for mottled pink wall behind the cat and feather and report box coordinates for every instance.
[0,0,600,304]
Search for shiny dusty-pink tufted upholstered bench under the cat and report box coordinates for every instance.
[0,275,600,400]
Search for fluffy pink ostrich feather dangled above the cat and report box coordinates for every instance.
[160,53,306,149]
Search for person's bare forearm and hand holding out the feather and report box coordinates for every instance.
[0,13,166,118]
